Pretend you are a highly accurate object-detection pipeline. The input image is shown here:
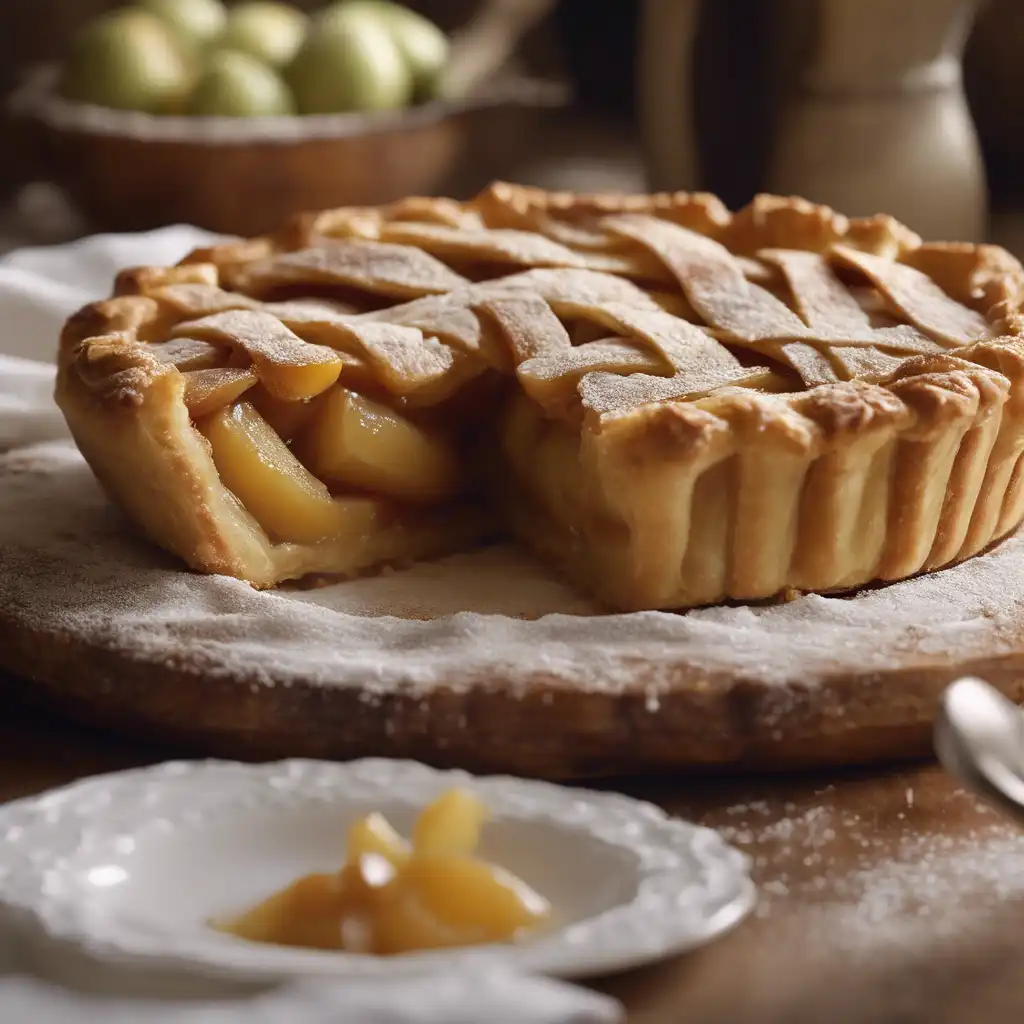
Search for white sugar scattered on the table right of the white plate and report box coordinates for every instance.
[715,769,1024,954]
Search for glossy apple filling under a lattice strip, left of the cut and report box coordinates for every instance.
[162,310,466,546]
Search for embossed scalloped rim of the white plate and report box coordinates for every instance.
[0,758,756,981]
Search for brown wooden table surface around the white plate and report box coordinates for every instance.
[6,679,1024,1024]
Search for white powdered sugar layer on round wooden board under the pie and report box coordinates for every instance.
[0,442,1024,700]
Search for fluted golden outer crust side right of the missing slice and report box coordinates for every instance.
[500,354,1024,609]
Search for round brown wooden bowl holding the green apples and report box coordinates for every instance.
[12,67,566,236]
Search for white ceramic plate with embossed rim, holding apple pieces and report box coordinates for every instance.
[0,760,755,981]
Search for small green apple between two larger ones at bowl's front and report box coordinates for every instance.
[185,50,295,118]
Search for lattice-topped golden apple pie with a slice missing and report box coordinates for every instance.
[56,183,1024,610]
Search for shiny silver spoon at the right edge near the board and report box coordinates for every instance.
[934,677,1024,824]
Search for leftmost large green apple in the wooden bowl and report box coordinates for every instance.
[60,7,195,114]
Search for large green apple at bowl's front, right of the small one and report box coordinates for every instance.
[288,3,413,114]
